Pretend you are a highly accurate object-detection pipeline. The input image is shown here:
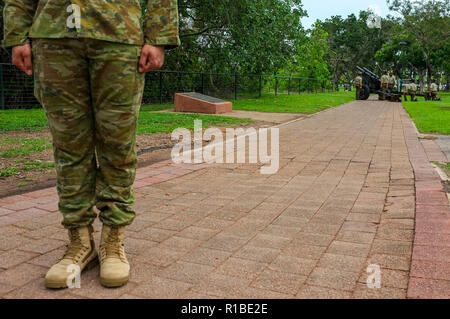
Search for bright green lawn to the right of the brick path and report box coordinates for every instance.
[403,93,450,135]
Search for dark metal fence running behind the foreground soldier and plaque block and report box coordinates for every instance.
[0,63,337,110]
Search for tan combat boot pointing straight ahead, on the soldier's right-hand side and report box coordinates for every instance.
[99,225,130,288]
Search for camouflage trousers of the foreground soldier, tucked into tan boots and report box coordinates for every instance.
[32,39,144,228]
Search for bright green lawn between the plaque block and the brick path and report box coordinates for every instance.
[233,91,355,114]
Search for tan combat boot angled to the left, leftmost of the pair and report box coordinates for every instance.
[45,226,97,289]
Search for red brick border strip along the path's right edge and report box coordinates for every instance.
[402,110,450,299]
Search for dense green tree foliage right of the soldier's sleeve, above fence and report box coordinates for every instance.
[160,0,306,74]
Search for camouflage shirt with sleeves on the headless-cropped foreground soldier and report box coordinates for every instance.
[3,0,180,48]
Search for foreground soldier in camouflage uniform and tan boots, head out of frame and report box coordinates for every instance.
[3,0,179,288]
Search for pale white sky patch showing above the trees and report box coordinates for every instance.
[302,0,392,29]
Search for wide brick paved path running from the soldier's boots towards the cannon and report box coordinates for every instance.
[0,101,450,298]
